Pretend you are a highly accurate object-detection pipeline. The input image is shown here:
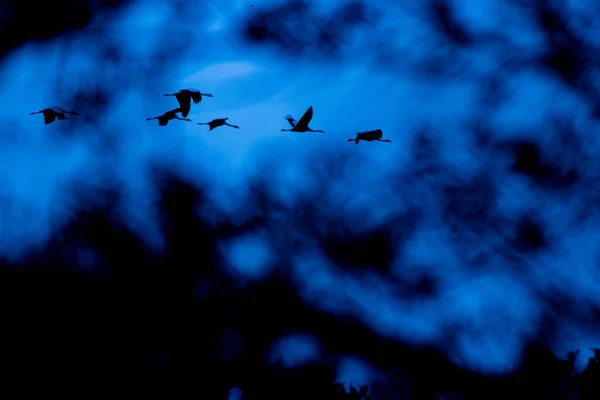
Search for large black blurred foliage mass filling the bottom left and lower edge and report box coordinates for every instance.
[0,164,600,399]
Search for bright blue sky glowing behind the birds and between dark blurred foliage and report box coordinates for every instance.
[0,0,600,390]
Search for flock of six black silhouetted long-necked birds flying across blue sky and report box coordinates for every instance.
[29,89,391,144]
